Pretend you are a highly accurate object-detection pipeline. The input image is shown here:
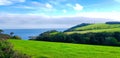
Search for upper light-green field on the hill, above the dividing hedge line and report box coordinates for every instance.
[73,24,120,31]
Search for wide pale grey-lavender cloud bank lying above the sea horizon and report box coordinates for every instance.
[0,14,115,29]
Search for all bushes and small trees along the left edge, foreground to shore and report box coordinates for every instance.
[0,31,31,58]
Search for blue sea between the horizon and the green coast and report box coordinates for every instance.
[3,28,67,40]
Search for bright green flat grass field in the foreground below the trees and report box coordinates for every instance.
[9,40,120,58]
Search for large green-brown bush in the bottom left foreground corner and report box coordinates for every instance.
[0,39,31,58]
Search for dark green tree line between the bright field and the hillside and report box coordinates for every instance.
[31,31,120,46]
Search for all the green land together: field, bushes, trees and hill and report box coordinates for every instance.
[0,22,120,58]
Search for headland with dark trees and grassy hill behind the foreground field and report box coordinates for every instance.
[33,22,120,46]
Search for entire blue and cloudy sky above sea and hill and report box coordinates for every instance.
[0,0,120,29]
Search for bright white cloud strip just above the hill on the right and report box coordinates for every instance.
[76,12,120,21]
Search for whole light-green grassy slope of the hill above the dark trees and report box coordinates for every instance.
[67,24,120,34]
